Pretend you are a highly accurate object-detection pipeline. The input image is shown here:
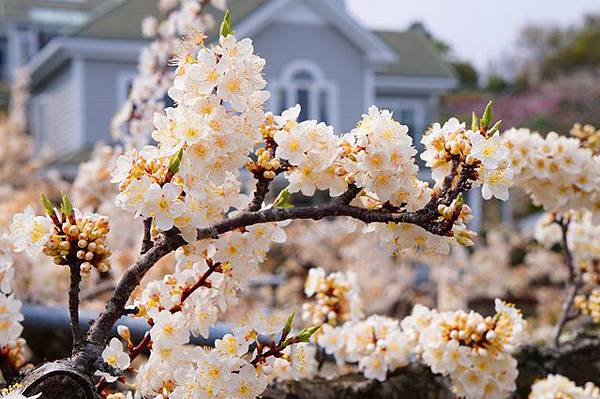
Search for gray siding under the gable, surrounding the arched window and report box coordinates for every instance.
[253,23,367,131]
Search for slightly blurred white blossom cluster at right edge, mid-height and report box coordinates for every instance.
[503,129,600,219]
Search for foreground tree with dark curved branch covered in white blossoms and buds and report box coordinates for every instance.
[0,1,598,399]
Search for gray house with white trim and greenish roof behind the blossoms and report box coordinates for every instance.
[5,0,456,159]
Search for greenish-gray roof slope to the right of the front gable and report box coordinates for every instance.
[375,31,454,78]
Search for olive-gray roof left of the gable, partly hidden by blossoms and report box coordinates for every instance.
[70,0,268,40]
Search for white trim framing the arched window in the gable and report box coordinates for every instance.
[269,59,339,126]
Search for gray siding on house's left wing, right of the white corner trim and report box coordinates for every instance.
[82,60,136,147]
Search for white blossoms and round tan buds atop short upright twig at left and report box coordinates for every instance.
[10,196,111,275]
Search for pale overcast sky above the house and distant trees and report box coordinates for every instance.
[347,0,600,71]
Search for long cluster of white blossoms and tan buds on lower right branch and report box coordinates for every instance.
[308,273,525,399]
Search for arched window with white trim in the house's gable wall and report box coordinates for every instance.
[271,60,337,125]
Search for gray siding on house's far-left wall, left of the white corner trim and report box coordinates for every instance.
[30,63,80,153]
